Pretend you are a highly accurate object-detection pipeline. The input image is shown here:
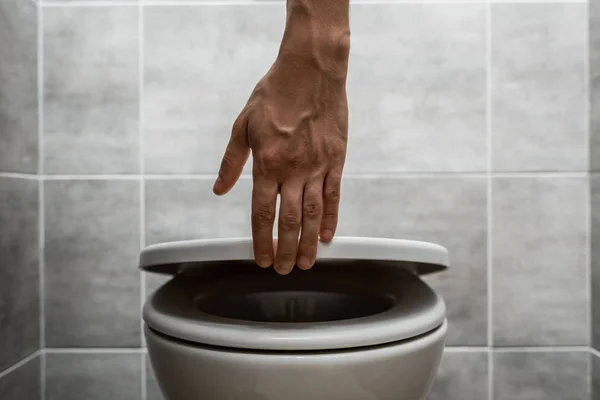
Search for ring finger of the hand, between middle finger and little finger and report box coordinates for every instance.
[297,179,323,269]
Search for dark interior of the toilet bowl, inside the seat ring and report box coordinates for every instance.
[189,260,407,323]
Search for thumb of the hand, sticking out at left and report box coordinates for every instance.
[213,118,250,196]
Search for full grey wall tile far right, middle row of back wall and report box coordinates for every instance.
[492,177,590,346]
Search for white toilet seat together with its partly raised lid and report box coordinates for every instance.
[140,237,449,351]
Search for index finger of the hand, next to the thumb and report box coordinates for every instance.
[252,177,278,268]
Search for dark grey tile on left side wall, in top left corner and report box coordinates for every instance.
[0,0,38,173]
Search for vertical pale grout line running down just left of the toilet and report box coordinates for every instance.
[138,1,148,400]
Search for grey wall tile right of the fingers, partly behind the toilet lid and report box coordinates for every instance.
[338,178,487,346]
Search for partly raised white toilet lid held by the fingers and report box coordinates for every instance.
[139,237,450,275]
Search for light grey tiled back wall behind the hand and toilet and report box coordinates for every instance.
[5,0,598,400]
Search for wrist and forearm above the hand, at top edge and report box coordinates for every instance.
[279,0,350,79]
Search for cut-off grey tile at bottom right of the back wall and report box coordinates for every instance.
[493,351,590,400]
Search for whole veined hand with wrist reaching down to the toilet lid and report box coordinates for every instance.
[213,0,350,274]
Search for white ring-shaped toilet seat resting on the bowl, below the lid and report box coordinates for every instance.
[143,272,446,351]
